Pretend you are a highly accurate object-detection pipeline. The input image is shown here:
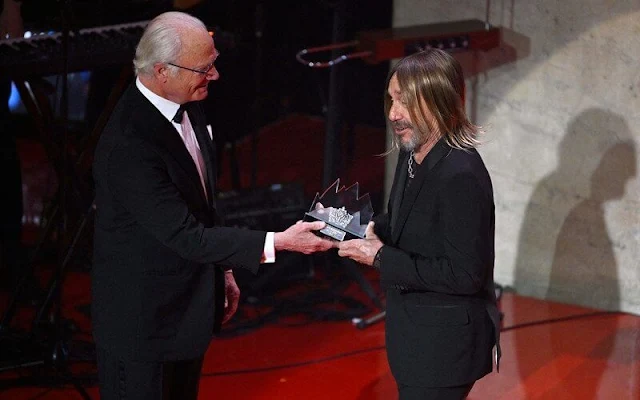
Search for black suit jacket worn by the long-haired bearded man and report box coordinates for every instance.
[375,140,497,387]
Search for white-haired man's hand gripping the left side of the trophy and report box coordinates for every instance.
[273,221,335,254]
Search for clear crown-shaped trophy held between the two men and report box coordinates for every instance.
[304,179,373,241]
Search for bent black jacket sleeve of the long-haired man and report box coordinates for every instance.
[381,173,493,295]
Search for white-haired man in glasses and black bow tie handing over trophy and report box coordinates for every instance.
[92,12,333,400]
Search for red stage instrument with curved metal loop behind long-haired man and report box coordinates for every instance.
[296,19,502,68]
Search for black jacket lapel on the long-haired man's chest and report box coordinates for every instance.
[391,139,452,243]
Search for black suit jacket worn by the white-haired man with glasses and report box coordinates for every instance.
[92,85,265,361]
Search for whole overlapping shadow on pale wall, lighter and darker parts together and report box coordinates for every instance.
[514,109,636,310]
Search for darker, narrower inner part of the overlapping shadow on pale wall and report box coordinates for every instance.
[547,141,636,311]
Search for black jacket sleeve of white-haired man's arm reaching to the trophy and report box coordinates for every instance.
[106,134,266,272]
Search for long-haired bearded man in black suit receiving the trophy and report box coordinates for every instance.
[339,49,500,400]
